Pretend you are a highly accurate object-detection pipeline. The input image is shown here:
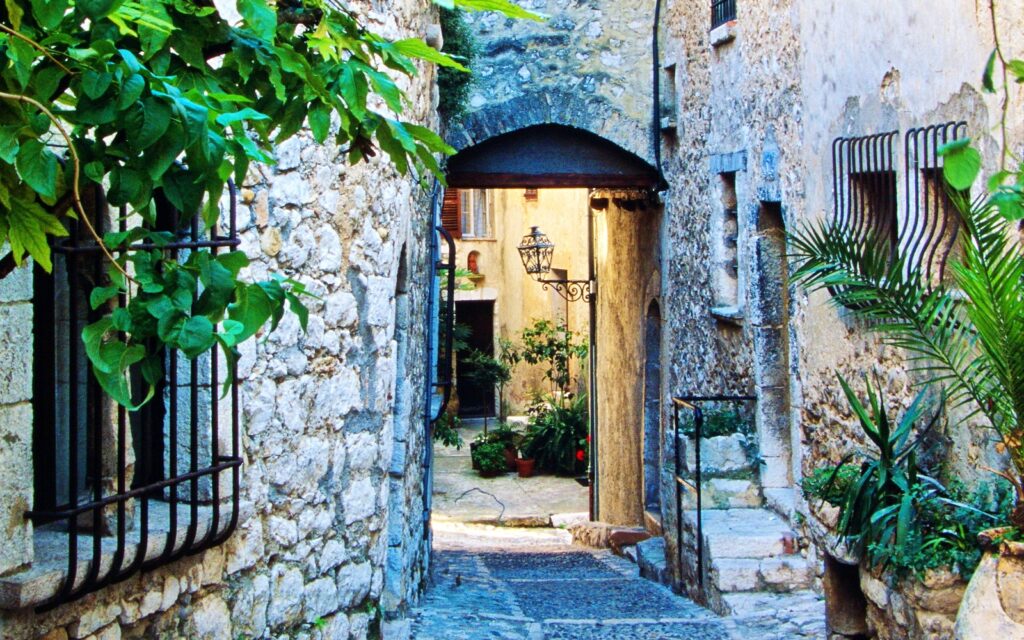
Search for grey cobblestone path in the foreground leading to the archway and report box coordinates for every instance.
[412,523,825,640]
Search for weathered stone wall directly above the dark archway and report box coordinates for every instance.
[449,0,653,163]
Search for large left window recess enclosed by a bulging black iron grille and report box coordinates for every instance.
[26,184,242,610]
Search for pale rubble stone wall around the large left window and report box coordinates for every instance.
[0,0,436,640]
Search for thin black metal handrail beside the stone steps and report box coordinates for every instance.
[672,395,757,593]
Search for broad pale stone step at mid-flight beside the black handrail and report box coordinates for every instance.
[686,509,798,559]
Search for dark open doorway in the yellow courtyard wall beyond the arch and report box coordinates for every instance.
[455,301,496,418]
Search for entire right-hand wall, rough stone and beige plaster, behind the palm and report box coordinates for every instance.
[660,0,1024,630]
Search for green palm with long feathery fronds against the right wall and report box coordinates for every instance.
[790,178,1024,527]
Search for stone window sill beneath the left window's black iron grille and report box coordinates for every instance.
[0,501,254,610]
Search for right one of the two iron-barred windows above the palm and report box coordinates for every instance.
[904,122,969,287]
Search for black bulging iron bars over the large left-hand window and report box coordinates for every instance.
[26,182,242,611]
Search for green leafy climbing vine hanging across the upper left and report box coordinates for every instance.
[0,0,537,406]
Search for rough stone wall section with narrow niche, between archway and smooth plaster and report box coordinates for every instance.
[660,2,804,577]
